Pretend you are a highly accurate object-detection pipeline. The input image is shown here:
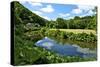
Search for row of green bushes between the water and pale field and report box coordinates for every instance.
[47,30,97,42]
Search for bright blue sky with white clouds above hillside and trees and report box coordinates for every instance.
[20,1,95,20]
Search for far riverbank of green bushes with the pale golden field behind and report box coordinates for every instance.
[45,29,97,42]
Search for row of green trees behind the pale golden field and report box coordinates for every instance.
[46,14,97,29]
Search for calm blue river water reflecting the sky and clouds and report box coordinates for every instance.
[35,37,97,58]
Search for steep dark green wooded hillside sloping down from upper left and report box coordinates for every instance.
[12,1,47,26]
